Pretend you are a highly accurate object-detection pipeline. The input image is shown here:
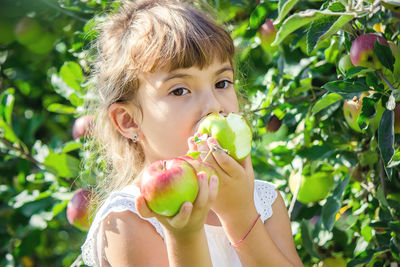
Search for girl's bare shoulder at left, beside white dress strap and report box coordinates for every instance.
[101,211,168,266]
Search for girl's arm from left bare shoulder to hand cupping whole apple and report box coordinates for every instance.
[102,172,218,267]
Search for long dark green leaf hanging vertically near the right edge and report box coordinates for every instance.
[378,110,394,170]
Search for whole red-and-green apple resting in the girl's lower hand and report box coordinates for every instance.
[140,158,199,216]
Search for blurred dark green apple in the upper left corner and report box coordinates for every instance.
[14,18,42,45]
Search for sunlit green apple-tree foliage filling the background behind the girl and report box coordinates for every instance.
[0,0,400,266]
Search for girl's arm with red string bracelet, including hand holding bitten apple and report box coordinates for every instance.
[195,138,302,267]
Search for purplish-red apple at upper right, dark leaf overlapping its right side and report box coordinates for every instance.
[350,33,389,69]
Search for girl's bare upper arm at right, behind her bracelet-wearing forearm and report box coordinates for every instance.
[264,190,303,266]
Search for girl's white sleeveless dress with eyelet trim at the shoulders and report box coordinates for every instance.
[82,180,277,267]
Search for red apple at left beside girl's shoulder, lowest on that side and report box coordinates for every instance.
[67,188,91,231]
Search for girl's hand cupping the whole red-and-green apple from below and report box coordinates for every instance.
[136,172,219,237]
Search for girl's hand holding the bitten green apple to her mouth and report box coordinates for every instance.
[188,137,255,219]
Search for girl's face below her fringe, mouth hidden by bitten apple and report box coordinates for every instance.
[138,61,239,163]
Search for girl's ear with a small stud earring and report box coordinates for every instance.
[108,103,139,139]
